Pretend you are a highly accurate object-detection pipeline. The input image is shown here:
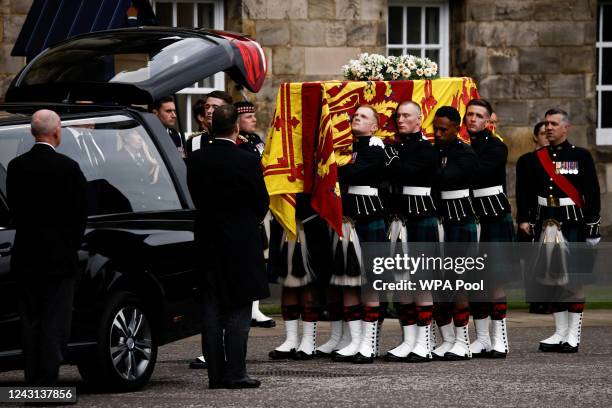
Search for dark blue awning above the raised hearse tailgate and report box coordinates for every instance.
[11,0,157,60]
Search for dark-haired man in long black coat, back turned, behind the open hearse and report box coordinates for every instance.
[187,105,270,388]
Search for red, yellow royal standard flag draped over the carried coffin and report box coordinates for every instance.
[262,77,478,237]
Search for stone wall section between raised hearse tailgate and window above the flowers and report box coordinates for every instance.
[237,0,387,132]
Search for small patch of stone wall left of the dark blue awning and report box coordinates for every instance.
[0,0,32,101]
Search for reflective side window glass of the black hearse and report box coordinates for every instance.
[0,115,181,215]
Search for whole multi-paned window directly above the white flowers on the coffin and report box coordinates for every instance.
[387,0,449,76]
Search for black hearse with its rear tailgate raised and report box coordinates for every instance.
[0,28,266,390]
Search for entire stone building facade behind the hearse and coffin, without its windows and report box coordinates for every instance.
[0,0,612,230]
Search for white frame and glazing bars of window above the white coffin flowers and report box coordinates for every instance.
[386,0,450,76]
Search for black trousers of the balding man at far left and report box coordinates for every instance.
[19,277,75,386]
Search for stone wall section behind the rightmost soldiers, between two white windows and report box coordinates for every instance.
[451,0,612,230]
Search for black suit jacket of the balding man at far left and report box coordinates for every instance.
[6,144,87,278]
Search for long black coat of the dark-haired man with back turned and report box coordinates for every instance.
[187,139,270,306]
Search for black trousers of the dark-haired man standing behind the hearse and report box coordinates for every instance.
[202,289,251,385]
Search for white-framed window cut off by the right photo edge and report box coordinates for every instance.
[597,2,612,145]
